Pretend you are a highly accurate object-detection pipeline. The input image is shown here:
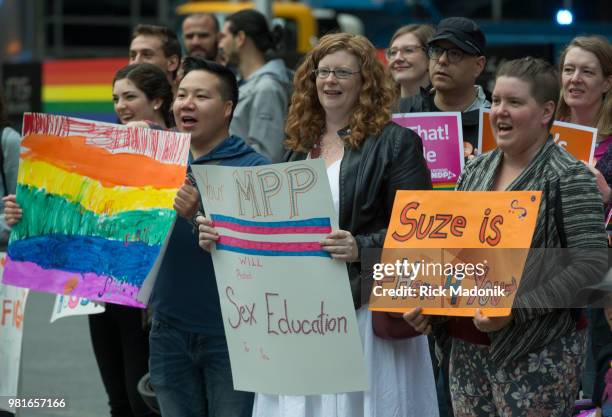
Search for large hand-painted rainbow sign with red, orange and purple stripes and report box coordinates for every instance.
[4,114,189,306]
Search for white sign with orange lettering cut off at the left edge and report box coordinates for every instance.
[0,252,28,413]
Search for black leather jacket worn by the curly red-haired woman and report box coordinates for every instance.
[285,122,431,308]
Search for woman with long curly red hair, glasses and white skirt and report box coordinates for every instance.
[246,33,438,417]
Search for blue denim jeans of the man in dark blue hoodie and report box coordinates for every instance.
[149,319,254,417]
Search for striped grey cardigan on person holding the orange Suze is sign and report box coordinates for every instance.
[457,137,607,363]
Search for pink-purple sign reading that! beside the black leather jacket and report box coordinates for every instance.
[393,112,464,189]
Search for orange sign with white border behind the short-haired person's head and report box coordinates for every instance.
[478,108,597,164]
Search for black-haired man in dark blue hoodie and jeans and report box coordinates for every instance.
[150,57,268,417]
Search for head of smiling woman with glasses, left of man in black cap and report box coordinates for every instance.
[385,24,434,97]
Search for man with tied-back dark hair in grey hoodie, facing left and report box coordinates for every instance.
[219,10,292,162]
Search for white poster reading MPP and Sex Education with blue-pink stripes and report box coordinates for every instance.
[192,159,367,395]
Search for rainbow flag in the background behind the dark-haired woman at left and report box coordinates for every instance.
[42,58,128,123]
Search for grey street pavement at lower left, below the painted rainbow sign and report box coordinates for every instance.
[17,291,110,417]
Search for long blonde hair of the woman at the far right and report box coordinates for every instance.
[556,35,612,138]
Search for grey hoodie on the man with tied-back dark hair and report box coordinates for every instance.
[230,59,293,162]
